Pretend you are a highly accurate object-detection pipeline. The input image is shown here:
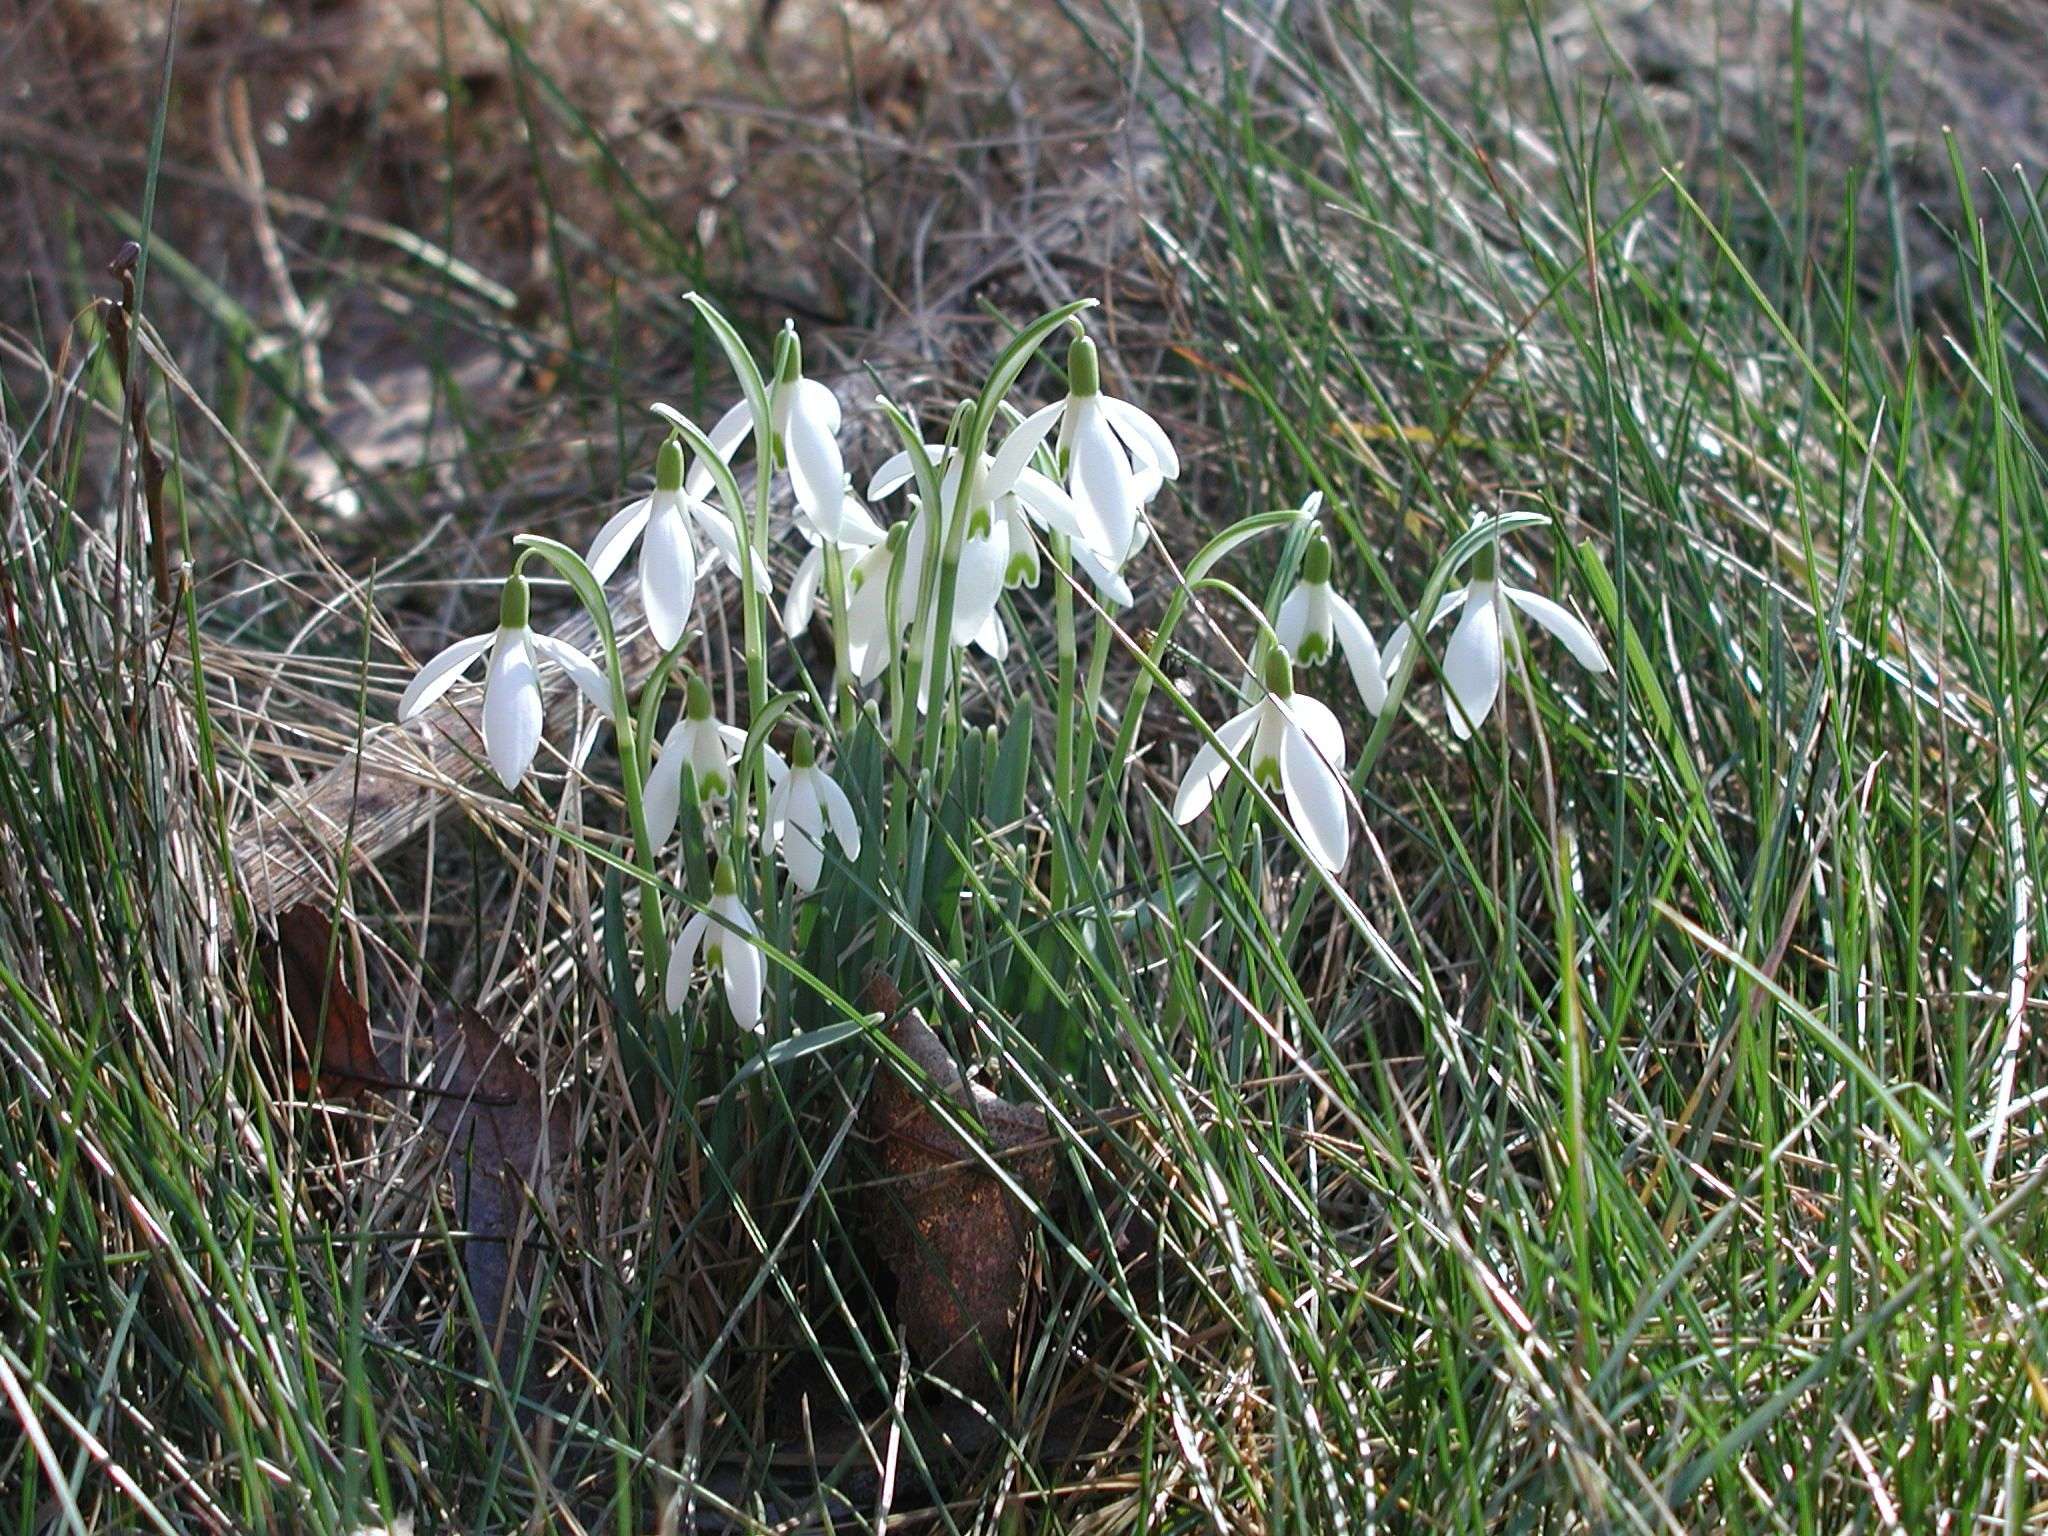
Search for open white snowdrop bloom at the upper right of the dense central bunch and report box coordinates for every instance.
[1001,336,1180,565]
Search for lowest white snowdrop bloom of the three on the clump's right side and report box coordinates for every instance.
[1174,649,1352,874]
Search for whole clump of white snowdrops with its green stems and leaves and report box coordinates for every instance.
[399,295,1608,1030]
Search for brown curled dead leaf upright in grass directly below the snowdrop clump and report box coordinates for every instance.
[864,979,1053,1391]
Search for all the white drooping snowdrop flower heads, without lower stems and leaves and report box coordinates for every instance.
[397,295,1608,1028]
